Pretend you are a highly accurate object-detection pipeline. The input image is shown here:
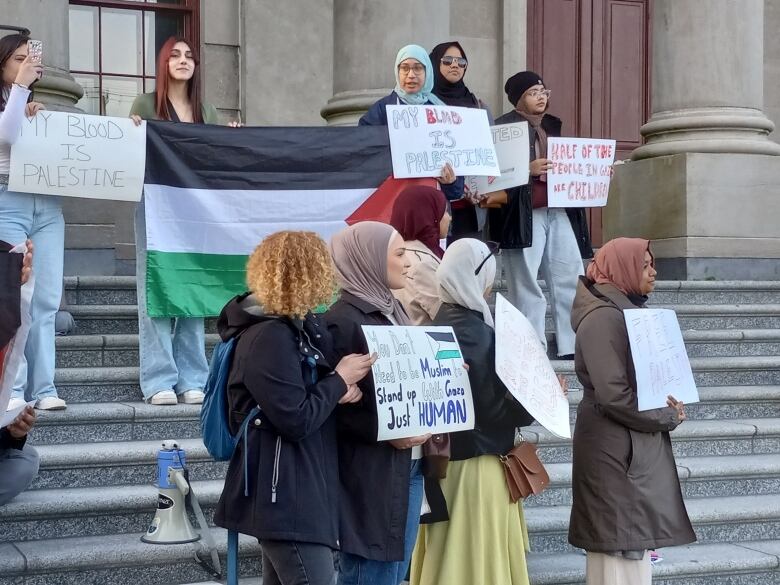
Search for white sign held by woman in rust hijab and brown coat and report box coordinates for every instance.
[623,309,699,411]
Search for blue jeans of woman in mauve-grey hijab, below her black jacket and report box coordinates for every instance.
[338,459,424,585]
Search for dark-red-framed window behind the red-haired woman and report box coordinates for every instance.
[69,0,199,117]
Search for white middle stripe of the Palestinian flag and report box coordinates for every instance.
[144,185,376,255]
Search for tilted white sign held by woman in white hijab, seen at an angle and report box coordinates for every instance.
[496,294,571,439]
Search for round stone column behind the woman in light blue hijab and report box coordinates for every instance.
[321,0,450,126]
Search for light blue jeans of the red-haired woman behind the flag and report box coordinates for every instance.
[135,201,209,398]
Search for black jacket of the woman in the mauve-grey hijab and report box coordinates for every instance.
[325,292,412,561]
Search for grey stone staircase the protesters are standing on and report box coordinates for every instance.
[0,277,780,585]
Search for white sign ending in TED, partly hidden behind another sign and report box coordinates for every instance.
[466,122,531,195]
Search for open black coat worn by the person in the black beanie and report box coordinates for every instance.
[487,110,593,258]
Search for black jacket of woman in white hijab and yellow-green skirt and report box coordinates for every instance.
[433,303,534,461]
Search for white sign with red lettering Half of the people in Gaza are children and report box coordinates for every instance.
[547,137,615,207]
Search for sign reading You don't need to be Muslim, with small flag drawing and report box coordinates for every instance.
[363,325,474,441]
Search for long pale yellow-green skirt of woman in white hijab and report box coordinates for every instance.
[411,455,529,585]
